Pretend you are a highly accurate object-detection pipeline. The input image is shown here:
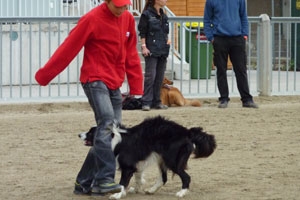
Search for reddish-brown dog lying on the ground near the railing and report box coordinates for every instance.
[160,77,201,107]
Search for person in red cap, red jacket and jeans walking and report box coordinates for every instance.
[35,0,143,194]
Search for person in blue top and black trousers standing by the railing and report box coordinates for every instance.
[204,0,258,108]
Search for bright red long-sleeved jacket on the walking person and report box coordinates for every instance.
[35,3,143,95]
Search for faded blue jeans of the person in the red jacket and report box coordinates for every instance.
[76,81,122,190]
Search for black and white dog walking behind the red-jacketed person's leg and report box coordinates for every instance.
[79,116,216,199]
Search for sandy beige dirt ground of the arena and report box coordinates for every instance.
[0,96,300,200]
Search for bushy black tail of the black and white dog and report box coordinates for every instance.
[190,127,217,158]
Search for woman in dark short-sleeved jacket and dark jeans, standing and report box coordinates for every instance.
[138,0,170,111]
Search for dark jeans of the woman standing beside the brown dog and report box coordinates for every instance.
[141,56,167,106]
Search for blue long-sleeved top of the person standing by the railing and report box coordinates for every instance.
[203,0,249,41]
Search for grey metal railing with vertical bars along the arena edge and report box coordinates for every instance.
[0,17,300,103]
